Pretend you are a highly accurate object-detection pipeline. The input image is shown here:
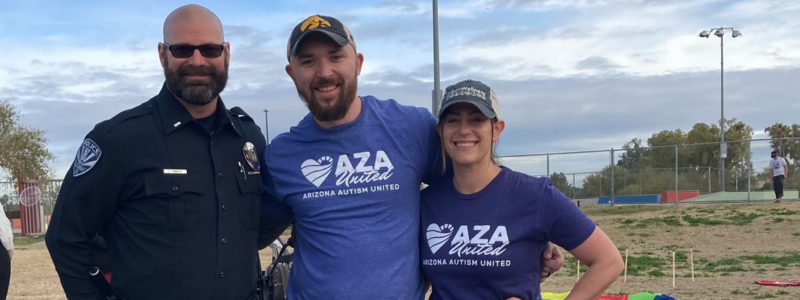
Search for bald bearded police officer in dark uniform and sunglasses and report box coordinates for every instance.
[46,5,266,300]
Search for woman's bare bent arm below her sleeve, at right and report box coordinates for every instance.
[565,227,625,300]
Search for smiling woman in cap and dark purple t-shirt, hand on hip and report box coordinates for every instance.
[420,80,623,300]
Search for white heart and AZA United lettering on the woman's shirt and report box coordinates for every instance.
[425,223,508,257]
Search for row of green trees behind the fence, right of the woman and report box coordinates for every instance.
[550,118,800,198]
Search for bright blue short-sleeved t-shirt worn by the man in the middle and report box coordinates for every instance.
[262,96,441,300]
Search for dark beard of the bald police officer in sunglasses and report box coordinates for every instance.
[164,62,228,105]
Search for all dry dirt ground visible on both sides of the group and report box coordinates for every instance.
[8,202,800,300]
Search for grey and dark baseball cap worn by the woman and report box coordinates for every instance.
[436,79,500,119]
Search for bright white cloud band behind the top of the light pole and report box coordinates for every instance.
[445,1,800,79]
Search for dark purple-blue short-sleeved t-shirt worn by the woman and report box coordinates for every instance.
[420,167,595,300]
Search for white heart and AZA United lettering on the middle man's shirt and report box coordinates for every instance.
[300,150,394,187]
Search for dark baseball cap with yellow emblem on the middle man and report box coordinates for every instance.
[286,15,356,59]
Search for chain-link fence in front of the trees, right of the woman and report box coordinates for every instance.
[501,138,800,204]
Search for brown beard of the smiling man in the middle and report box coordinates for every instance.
[296,77,358,122]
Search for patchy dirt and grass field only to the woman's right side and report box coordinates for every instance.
[542,202,800,300]
